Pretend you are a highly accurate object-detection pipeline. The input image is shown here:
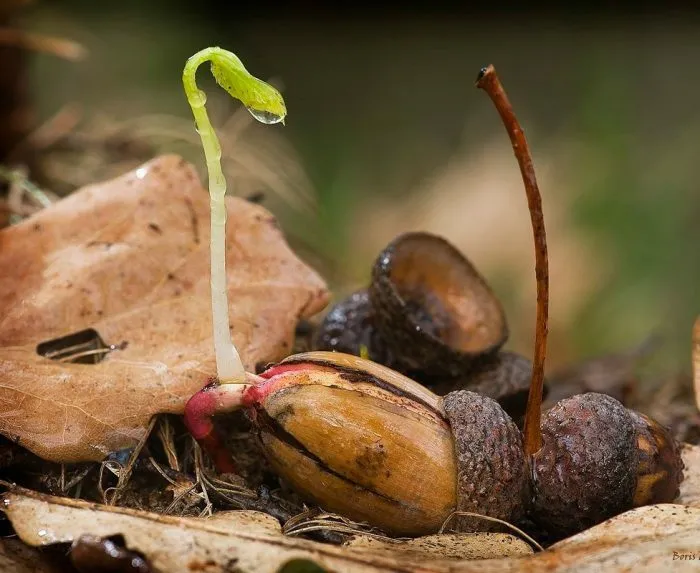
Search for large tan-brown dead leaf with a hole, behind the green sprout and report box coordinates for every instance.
[0,156,328,462]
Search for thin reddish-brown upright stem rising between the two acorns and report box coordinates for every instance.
[476,66,549,456]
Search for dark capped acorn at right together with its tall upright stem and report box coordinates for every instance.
[476,66,683,537]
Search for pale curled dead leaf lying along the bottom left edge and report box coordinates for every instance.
[2,488,532,573]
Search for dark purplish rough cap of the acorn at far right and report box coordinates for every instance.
[532,392,638,537]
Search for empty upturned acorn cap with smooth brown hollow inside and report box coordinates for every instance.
[369,233,508,376]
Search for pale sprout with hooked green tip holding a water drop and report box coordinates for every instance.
[182,48,287,384]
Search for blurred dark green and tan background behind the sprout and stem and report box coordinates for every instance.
[8,0,700,372]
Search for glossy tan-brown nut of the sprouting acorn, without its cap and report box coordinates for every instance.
[250,352,457,535]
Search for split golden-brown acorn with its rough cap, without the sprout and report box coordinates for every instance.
[248,352,527,536]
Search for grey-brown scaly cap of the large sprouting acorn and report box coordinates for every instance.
[443,390,528,531]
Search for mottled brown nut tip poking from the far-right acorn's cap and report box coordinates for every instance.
[630,410,684,507]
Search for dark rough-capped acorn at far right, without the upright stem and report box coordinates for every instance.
[532,392,683,536]
